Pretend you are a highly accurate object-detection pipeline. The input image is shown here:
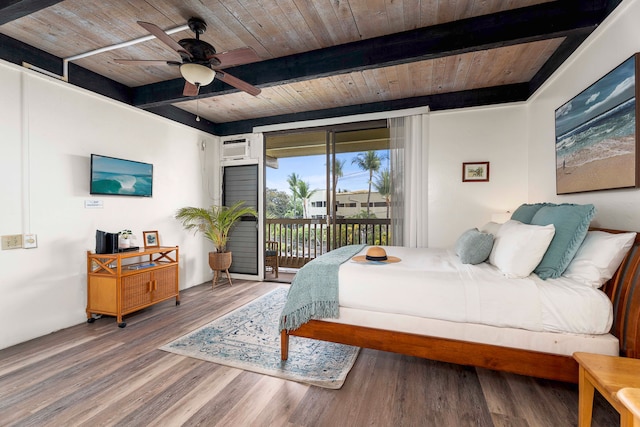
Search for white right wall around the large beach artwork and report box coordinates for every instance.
[528,0,640,230]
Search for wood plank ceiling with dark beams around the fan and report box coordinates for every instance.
[0,0,620,135]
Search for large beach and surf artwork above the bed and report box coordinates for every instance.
[555,54,639,194]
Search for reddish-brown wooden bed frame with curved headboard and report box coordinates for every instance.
[280,229,640,383]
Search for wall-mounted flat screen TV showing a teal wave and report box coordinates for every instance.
[89,154,153,197]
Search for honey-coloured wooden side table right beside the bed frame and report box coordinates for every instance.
[573,353,640,427]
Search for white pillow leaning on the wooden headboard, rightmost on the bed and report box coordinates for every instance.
[563,231,636,288]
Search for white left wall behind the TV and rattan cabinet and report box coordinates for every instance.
[0,62,219,348]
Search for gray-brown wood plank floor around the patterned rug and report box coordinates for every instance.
[0,280,619,427]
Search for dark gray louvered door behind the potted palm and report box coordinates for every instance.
[222,165,258,275]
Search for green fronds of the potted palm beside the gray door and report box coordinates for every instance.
[175,201,258,252]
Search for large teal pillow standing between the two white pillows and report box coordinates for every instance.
[531,203,596,279]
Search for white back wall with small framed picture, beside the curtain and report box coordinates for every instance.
[429,104,528,247]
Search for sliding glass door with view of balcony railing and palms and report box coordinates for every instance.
[265,121,389,268]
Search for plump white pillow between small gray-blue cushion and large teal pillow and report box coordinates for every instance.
[489,220,556,278]
